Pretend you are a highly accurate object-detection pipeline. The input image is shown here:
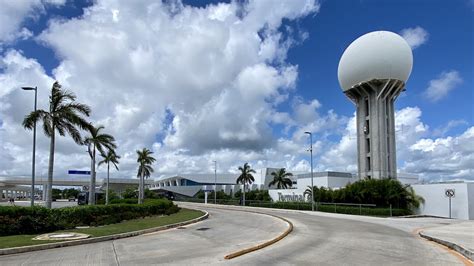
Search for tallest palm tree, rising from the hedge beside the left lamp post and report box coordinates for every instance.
[23,81,91,209]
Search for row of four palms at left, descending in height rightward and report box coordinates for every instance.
[23,81,155,209]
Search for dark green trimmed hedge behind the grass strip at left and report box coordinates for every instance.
[0,199,180,236]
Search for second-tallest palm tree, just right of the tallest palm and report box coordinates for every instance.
[84,125,117,205]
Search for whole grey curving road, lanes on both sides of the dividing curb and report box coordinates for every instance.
[0,204,462,265]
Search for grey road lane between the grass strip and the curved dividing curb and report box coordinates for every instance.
[0,209,287,266]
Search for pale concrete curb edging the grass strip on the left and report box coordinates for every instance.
[0,210,209,256]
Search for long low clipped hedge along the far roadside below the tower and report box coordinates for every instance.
[250,202,412,216]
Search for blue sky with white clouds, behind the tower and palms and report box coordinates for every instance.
[0,0,474,181]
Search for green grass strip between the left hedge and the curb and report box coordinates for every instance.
[0,209,204,248]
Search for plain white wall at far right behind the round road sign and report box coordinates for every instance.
[411,182,474,220]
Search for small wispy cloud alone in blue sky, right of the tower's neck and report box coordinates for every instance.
[424,70,462,102]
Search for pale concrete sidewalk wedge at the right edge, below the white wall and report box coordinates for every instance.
[420,221,474,261]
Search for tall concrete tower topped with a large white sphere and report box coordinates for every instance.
[338,31,413,179]
